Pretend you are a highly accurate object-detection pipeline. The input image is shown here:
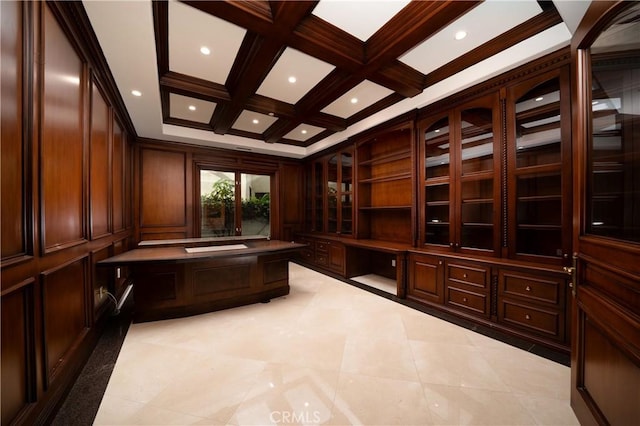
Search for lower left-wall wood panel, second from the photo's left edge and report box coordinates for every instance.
[41,257,89,380]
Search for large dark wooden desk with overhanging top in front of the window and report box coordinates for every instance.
[98,238,304,322]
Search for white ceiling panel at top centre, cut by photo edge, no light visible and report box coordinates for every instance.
[313,0,409,41]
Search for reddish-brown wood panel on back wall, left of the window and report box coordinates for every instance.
[140,149,187,226]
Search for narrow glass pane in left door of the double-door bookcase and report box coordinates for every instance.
[423,116,453,246]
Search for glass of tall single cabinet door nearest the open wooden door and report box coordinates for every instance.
[508,72,570,259]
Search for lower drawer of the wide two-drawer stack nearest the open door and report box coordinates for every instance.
[499,300,562,338]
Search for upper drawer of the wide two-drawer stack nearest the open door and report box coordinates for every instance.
[499,271,563,305]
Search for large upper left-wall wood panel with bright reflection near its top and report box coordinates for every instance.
[39,7,86,252]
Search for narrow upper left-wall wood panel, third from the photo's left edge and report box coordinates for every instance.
[89,82,111,240]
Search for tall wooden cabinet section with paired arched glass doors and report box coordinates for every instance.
[419,93,502,256]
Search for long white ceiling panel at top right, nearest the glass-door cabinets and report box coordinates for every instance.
[399,0,542,74]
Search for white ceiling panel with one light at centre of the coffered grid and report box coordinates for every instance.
[256,48,335,104]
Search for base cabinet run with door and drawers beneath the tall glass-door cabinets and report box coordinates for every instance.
[407,252,569,353]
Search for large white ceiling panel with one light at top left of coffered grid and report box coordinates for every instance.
[169,1,246,84]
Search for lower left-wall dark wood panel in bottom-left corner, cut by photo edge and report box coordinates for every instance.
[0,280,34,424]
